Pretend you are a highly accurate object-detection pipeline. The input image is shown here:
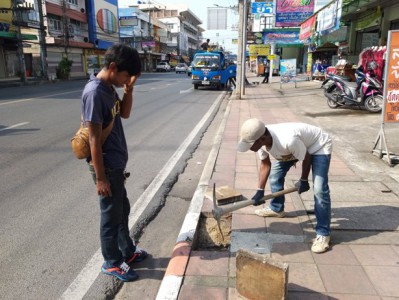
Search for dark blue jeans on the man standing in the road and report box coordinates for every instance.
[90,166,136,267]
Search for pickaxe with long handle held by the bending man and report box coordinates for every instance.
[212,184,298,237]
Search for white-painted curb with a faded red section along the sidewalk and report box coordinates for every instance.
[156,92,231,300]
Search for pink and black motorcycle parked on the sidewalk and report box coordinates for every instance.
[321,65,384,113]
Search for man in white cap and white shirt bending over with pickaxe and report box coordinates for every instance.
[238,119,332,253]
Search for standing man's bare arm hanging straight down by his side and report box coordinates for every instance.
[86,122,112,196]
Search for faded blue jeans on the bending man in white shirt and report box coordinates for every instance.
[269,155,331,236]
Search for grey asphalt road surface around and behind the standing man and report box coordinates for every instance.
[0,73,228,299]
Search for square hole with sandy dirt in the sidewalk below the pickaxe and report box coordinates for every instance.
[196,214,231,249]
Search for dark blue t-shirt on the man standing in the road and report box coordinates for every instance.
[82,75,128,169]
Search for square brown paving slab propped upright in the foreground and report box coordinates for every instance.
[236,249,288,300]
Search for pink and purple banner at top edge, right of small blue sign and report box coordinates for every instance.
[276,0,315,27]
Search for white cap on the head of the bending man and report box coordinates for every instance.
[237,119,265,152]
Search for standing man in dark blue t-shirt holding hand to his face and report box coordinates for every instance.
[82,45,147,281]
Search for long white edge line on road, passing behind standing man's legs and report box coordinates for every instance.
[60,93,228,300]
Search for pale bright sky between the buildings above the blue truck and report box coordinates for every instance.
[118,0,238,53]
